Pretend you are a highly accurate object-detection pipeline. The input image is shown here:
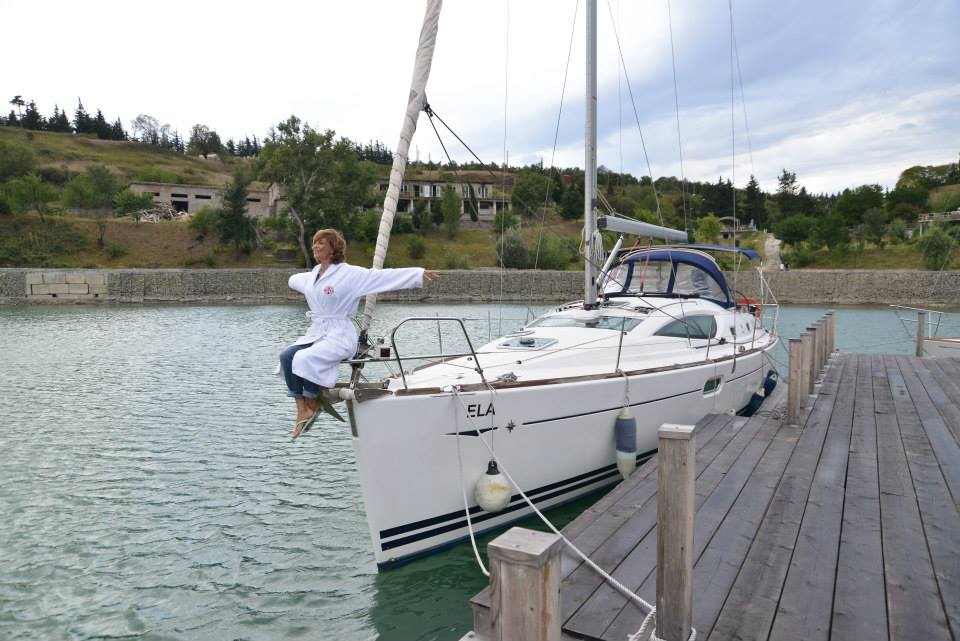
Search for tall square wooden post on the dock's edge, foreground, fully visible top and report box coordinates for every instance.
[656,423,696,641]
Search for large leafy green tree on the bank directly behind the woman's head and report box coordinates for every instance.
[257,116,377,267]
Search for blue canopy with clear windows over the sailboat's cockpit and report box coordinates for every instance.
[603,245,740,307]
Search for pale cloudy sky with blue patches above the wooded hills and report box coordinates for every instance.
[0,0,960,193]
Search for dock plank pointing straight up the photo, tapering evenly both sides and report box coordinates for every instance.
[830,355,888,641]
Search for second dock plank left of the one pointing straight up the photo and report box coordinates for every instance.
[694,352,846,639]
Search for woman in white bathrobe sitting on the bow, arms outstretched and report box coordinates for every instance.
[280,229,439,438]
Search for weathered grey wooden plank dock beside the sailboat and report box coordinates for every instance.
[472,354,960,641]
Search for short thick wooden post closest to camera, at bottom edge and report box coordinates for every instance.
[487,527,561,641]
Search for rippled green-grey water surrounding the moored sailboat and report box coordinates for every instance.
[0,305,956,640]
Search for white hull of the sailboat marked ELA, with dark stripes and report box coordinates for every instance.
[348,340,775,566]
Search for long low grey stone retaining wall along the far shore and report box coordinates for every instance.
[0,269,960,307]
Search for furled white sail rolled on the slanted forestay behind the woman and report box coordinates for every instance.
[360,0,443,330]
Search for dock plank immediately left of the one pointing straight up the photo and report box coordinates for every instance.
[770,350,857,641]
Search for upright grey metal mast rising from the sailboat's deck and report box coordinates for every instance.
[583,0,597,308]
